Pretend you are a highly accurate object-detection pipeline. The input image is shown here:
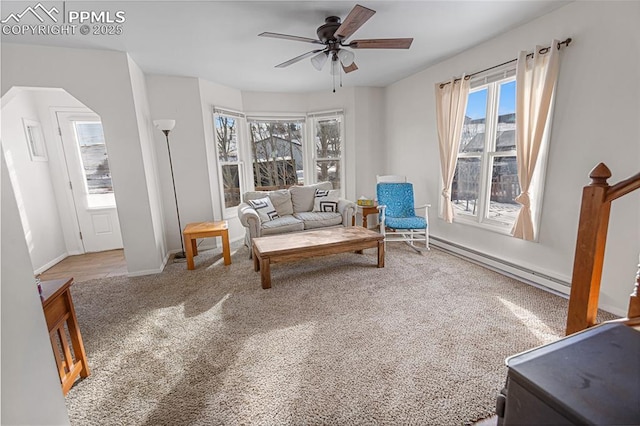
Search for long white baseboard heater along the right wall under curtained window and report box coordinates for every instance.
[430,236,571,299]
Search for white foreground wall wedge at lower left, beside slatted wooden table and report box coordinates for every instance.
[0,153,69,425]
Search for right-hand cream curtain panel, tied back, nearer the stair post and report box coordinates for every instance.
[511,40,560,241]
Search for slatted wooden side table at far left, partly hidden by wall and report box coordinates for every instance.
[40,278,91,395]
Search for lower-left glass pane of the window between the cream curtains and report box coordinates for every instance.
[451,157,481,216]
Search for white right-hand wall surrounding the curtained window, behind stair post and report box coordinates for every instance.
[386,2,640,314]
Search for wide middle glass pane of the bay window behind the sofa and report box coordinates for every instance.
[249,121,304,190]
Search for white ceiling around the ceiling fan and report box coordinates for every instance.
[0,0,568,92]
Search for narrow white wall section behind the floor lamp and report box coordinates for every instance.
[147,75,213,250]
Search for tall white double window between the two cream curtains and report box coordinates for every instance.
[451,71,520,231]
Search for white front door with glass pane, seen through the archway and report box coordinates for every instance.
[56,111,122,252]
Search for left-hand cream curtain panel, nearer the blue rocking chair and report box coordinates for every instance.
[436,76,469,223]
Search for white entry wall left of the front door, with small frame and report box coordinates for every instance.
[0,90,67,273]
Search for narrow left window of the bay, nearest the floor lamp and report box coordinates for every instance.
[214,110,245,217]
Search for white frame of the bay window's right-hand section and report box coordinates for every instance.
[305,110,346,198]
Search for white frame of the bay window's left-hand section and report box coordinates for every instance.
[213,108,248,219]
